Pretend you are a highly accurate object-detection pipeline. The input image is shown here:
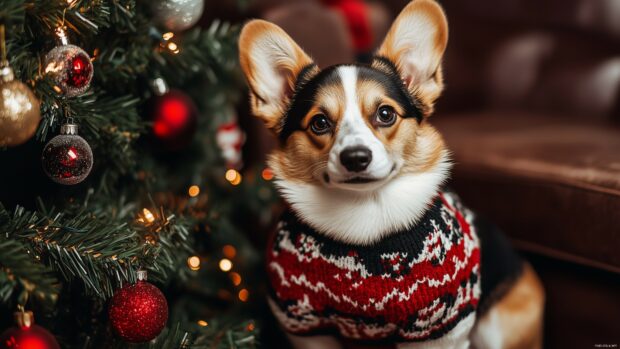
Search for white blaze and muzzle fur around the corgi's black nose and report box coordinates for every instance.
[319,66,402,191]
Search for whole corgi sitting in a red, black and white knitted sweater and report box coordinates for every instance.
[239,0,544,349]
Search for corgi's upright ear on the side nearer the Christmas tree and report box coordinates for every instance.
[239,19,318,133]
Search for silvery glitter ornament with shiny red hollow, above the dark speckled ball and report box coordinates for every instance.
[43,45,94,97]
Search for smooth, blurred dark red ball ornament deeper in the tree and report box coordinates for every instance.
[147,90,198,150]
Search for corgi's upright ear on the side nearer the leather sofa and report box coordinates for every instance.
[373,0,448,116]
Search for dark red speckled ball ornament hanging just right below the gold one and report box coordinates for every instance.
[41,124,93,185]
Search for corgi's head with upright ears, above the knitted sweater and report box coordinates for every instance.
[239,0,448,245]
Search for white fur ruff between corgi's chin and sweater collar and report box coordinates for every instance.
[276,152,451,245]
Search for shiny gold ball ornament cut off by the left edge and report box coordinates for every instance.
[0,64,41,147]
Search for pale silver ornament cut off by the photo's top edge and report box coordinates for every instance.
[153,0,204,31]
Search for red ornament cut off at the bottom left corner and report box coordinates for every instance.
[0,311,60,349]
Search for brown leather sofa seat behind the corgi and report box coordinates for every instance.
[432,112,620,272]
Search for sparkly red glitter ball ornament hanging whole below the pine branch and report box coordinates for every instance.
[109,270,168,343]
